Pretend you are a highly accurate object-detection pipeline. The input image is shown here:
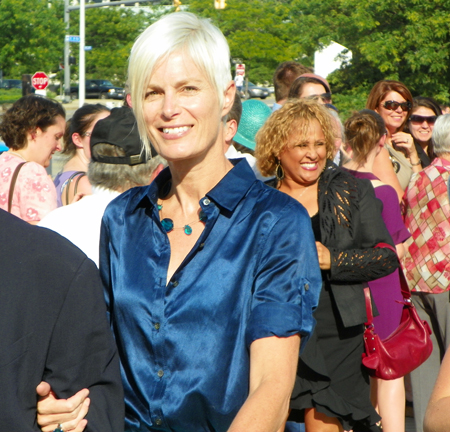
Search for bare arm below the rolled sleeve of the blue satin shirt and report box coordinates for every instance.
[228,335,300,432]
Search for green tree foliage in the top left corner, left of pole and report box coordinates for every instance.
[0,0,64,78]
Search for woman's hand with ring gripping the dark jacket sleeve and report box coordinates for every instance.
[36,381,90,432]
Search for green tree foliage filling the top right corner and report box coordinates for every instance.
[291,0,450,101]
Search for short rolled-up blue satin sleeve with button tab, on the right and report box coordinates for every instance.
[246,200,322,347]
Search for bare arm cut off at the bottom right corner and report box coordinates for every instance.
[423,350,450,432]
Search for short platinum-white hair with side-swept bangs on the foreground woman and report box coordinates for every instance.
[128,12,231,154]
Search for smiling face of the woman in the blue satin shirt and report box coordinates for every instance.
[143,52,229,161]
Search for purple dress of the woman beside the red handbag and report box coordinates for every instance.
[344,168,411,339]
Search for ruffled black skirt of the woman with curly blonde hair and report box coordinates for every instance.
[289,284,380,432]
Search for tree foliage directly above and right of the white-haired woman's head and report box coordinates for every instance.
[188,0,299,82]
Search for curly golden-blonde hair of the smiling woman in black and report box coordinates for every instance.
[255,99,335,177]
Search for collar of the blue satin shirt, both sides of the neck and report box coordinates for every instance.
[130,159,256,212]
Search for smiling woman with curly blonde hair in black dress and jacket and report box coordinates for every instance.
[256,100,397,432]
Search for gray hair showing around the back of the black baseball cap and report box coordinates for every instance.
[88,144,167,191]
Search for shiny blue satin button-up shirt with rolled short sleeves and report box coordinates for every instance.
[100,159,321,432]
